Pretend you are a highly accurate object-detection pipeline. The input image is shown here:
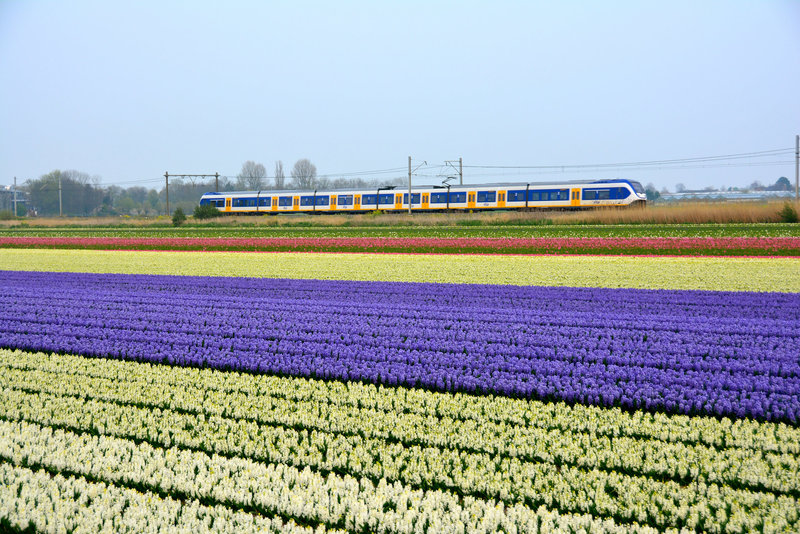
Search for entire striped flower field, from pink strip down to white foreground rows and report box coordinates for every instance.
[0,231,800,533]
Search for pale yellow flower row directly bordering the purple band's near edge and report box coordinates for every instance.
[0,349,800,455]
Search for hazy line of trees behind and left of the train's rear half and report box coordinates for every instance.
[18,159,403,217]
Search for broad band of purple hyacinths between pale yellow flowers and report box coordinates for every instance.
[0,272,800,423]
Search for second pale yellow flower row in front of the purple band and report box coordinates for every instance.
[0,356,800,495]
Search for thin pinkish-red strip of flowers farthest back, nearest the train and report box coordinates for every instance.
[0,236,800,256]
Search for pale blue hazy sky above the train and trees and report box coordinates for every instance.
[0,0,800,193]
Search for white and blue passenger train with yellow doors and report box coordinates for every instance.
[200,180,647,214]
